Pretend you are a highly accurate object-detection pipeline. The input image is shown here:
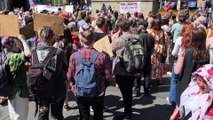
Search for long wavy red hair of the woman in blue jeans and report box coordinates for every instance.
[181,22,194,49]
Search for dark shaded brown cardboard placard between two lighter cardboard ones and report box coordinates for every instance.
[20,23,36,40]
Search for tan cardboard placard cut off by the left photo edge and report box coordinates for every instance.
[0,15,19,37]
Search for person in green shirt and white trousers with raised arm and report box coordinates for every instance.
[1,35,31,120]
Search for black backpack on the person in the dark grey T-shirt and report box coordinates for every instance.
[27,48,57,103]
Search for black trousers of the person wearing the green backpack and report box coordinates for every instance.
[115,75,135,116]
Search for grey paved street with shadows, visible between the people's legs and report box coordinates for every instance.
[0,74,172,120]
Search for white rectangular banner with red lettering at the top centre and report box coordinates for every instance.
[120,2,140,13]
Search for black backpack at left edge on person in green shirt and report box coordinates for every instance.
[0,54,12,97]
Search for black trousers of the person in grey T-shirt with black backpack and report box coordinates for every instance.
[38,97,65,120]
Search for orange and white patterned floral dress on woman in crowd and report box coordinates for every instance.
[150,29,168,79]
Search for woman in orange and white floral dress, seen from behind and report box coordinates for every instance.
[150,20,169,85]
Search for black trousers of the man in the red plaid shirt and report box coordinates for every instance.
[76,95,104,120]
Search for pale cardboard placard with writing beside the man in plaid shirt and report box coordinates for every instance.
[93,35,113,57]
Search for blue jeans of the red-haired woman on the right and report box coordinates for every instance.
[169,60,179,104]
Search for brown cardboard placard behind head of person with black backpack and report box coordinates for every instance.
[34,13,64,35]
